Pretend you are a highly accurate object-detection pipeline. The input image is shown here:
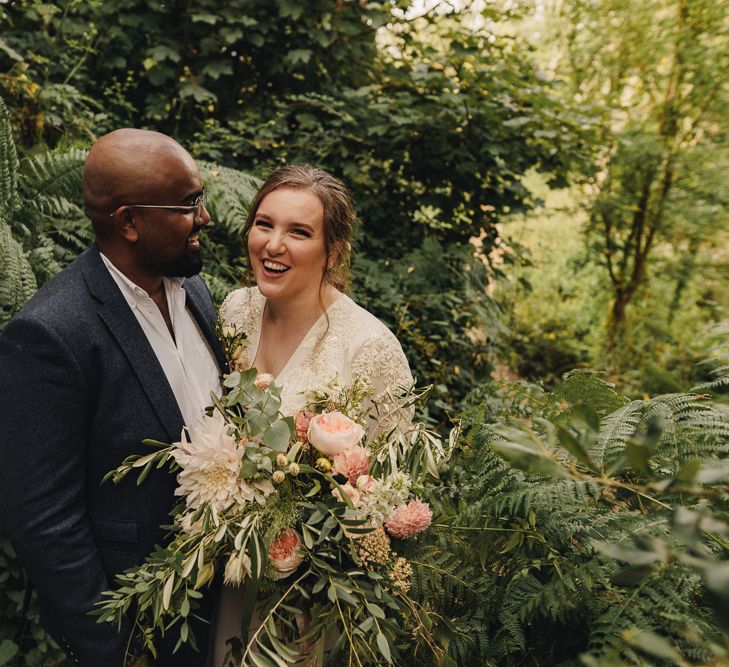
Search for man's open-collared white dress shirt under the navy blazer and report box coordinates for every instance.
[101,254,221,426]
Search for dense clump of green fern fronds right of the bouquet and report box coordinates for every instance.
[416,372,729,665]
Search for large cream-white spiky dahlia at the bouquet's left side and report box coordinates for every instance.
[172,410,274,511]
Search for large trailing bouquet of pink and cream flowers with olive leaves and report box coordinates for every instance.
[99,326,447,667]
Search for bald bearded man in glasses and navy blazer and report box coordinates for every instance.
[0,129,225,667]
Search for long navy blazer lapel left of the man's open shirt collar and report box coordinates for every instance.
[83,246,184,441]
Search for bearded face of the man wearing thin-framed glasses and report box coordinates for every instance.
[133,155,210,278]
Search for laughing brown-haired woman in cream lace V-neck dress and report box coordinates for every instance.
[213,165,413,667]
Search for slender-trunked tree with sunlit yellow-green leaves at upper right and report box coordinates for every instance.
[551,0,729,345]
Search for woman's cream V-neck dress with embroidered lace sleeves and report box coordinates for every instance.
[212,287,413,667]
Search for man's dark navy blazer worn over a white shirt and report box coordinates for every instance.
[0,246,225,667]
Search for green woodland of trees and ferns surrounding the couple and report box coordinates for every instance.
[0,0,729,665]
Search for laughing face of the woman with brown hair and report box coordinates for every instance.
[248,188,326,300]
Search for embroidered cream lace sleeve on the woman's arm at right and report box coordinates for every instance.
[352,330,414,439]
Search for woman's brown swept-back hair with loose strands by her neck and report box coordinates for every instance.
[243,164,357,290]
